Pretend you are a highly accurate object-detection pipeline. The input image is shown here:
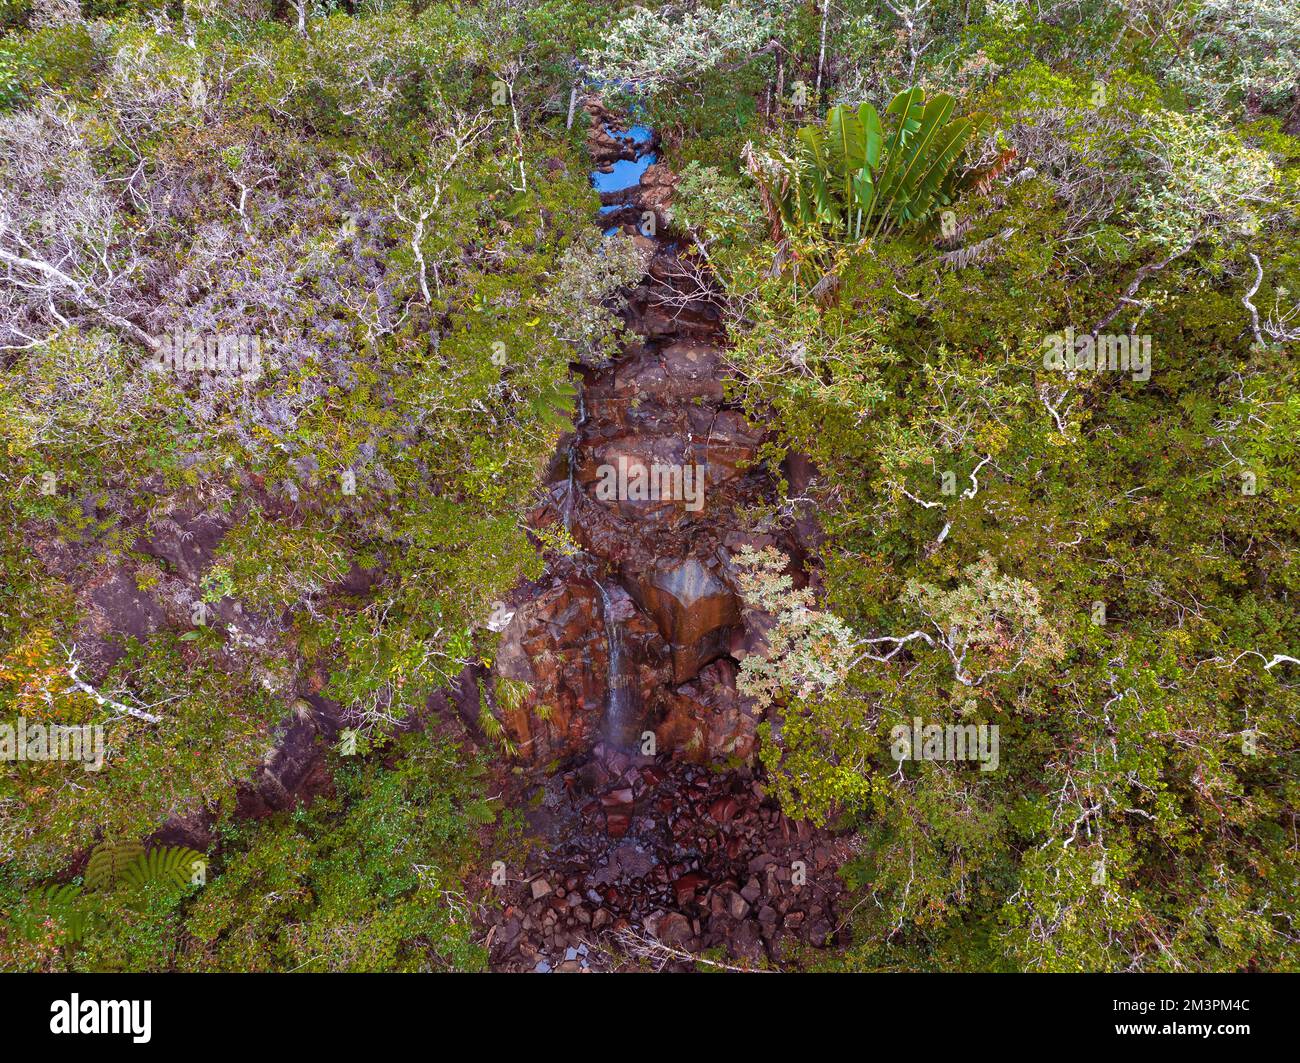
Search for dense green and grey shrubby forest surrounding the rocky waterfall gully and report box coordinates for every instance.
[0,0,1300,971]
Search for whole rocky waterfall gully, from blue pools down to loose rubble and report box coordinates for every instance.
[488,103,848,971]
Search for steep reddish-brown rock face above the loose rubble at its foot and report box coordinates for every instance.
[495,107,800,769]
